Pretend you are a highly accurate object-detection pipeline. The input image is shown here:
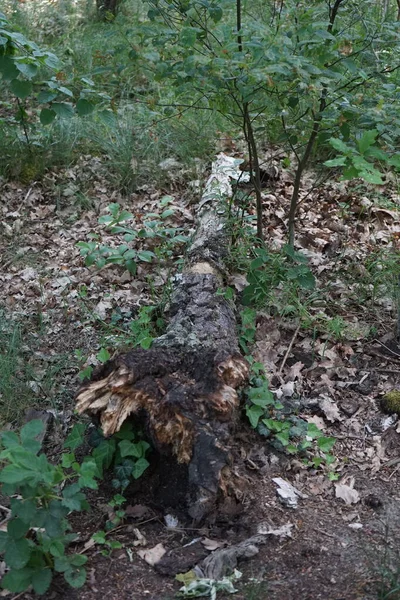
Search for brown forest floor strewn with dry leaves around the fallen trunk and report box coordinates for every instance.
[0,157,400,600]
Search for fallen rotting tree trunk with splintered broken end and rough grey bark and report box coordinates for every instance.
[76,155,249,521]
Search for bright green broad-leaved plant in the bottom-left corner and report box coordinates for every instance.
[0,420,97,594]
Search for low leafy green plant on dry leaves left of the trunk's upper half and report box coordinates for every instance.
[77,202,188,275]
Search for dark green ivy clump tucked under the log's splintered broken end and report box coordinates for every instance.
[90,422,150,490]
